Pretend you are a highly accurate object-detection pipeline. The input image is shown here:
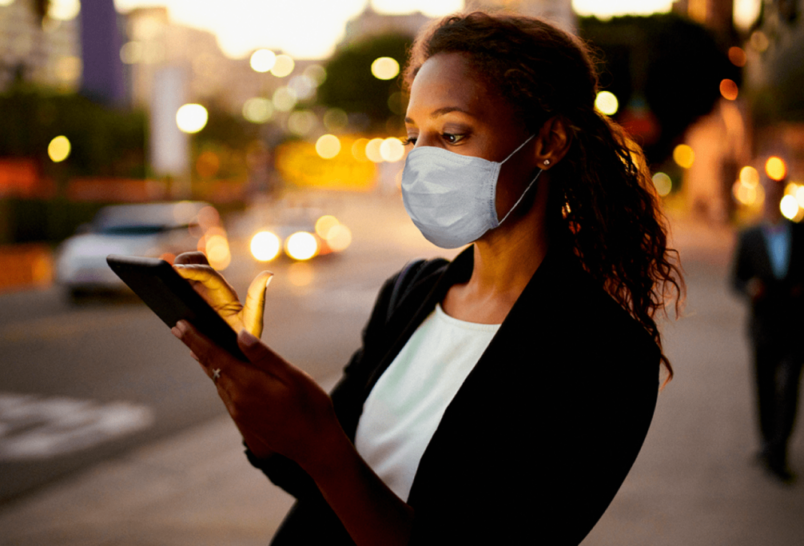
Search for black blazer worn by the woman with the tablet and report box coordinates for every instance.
[250,248,660,545]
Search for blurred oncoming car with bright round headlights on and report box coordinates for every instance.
[250,207,352,262]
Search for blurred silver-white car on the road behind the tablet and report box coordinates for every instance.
[56,201,230,296]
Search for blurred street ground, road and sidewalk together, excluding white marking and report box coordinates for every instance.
[0,195,804,546]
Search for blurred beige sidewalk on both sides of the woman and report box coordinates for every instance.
[0,214,804,546]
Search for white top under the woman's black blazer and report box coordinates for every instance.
[355,305,500,500]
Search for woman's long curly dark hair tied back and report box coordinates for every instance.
[403,11,685,380]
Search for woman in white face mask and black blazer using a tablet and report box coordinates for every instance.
[174,12,682,545]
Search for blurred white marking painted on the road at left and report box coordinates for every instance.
[0,392,154,461]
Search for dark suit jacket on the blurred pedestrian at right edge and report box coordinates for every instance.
[731,220,804,345]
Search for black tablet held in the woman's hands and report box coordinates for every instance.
[106,254,248,362]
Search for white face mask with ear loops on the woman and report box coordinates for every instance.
[402,135,542,248]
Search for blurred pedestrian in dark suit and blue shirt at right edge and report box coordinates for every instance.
[732,174,804,482]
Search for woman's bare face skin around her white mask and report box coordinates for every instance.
[405,53,537,218]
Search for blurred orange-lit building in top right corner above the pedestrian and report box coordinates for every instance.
[674,0,804,222]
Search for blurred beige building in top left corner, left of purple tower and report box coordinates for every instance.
[0,0,81,91]
